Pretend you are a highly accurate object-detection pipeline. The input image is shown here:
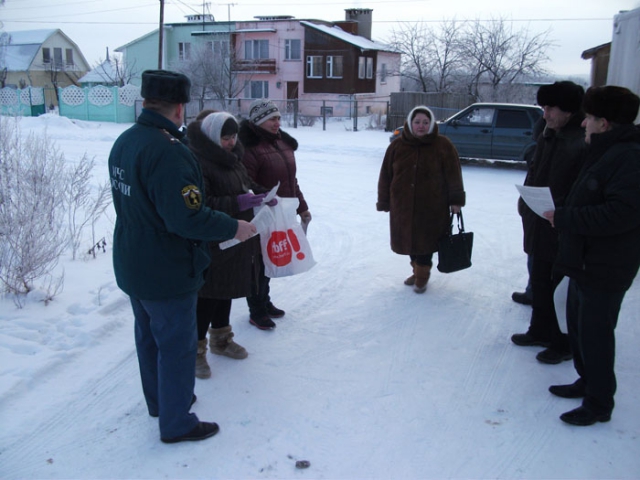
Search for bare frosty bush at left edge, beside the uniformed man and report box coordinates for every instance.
[0,117,111,306]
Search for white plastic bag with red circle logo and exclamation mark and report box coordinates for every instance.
[260,197,316,278]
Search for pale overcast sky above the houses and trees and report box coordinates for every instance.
[0,0,640,75]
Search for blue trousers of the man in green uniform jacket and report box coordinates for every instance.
[131,292,198,438]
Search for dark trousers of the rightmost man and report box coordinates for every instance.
[567,279,626,413]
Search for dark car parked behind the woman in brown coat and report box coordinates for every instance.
[394,103,543,161]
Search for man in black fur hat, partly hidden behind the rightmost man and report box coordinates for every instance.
[511,81,586,364]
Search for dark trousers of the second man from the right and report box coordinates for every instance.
[528,255,570,352]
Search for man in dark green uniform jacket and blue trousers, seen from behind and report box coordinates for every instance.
[109,70,255,443]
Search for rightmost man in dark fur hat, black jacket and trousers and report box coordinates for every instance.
[544,86,640,425]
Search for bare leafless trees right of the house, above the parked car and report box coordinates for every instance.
[387,18,553,100]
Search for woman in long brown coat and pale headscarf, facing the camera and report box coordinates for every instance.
[376,106,465,293]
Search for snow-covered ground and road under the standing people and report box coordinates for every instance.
[0,115,640,479]
